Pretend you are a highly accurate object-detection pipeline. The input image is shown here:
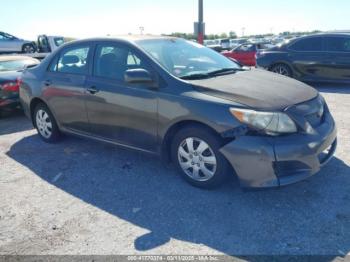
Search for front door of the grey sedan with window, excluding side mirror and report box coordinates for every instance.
[86,43,158,151]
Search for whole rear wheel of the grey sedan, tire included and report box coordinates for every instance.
[33,103,61,143]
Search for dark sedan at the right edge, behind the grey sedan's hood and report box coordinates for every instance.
[256,33,350,83]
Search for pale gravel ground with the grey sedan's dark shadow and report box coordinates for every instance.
[0,86,350,257]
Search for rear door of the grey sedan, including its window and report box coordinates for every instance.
[43,44,92,132]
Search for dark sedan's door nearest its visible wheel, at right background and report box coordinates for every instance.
[288,36,328,80]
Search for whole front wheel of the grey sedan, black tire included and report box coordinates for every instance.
[171,126,229,189]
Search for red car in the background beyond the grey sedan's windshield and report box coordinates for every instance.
[222,43,271,66]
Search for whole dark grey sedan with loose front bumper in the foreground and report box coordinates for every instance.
[20,36,337,188]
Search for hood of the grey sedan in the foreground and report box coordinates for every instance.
[191,69,318,110]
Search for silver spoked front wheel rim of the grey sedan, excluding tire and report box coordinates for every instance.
[178,137,217,182]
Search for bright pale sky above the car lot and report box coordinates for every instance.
[0,0,350,40]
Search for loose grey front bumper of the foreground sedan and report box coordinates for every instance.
[220,110,337,188]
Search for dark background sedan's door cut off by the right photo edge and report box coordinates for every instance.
[325,36,350,82]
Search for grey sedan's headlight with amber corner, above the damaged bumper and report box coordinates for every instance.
[230,108,297,135]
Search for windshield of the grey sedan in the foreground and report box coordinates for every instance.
[138,39,241,78]
